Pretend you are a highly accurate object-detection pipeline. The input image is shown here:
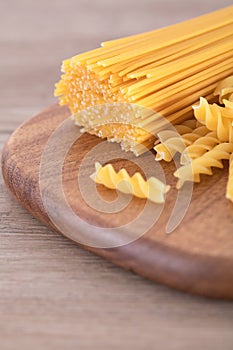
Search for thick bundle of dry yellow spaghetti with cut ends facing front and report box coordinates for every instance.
[55,6,233,154]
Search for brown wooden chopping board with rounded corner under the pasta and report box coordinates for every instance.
[2,105,233,299]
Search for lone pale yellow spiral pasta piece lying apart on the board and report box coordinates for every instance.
[90,162,170,203]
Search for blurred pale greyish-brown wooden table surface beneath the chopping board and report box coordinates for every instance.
[0,0,233,350]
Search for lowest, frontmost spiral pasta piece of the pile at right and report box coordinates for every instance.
[174,142,233,189]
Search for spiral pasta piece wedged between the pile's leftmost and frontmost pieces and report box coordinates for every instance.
[180,131,220,164]
